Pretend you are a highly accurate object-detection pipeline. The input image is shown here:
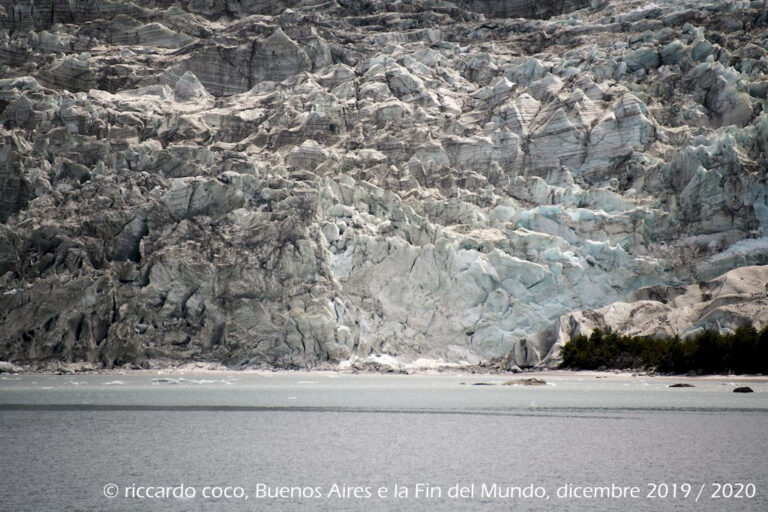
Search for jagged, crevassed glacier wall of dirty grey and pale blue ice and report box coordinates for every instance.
[0,0,768,367]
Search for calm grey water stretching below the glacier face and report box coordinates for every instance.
[0,373,768,512]
